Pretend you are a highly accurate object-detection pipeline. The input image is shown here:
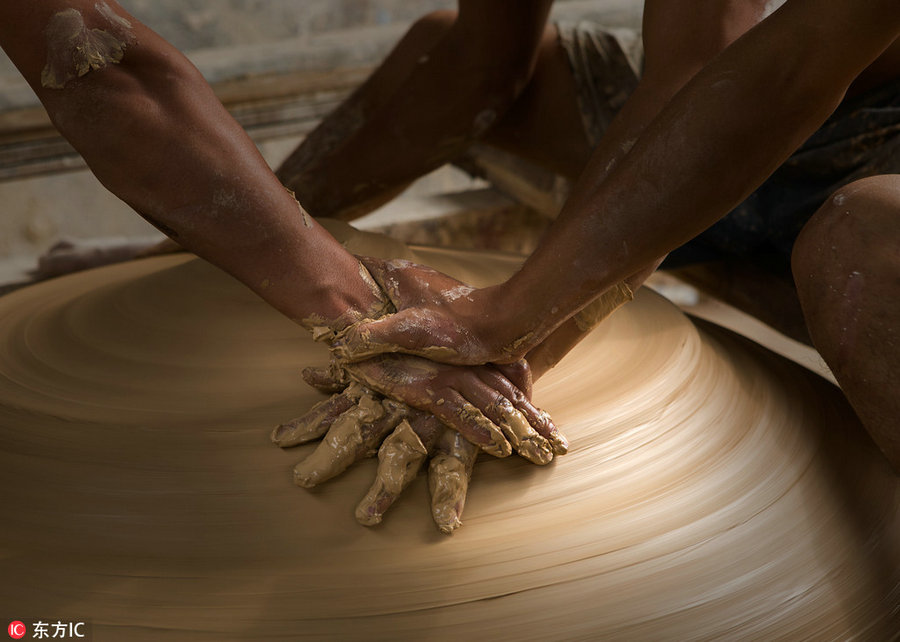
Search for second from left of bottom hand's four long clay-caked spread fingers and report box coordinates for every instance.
[294,391,405,488]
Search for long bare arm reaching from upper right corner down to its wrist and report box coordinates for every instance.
[496,2,896,350]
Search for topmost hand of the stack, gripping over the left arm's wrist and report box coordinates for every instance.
[332,257,536,365]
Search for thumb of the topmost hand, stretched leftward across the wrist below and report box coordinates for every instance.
[331,308,467,365]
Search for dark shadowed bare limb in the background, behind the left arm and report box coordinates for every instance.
[278,0,552,220]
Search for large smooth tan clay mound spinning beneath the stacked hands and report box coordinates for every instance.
[0,242,900,640]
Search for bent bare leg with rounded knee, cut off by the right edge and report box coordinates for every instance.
[793,175,900,472]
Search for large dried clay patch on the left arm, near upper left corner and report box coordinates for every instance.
[41,2,135,89]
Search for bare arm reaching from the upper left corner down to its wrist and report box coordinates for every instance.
[0,0,377,323]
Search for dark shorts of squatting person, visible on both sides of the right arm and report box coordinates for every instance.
[558,22,900,278]
